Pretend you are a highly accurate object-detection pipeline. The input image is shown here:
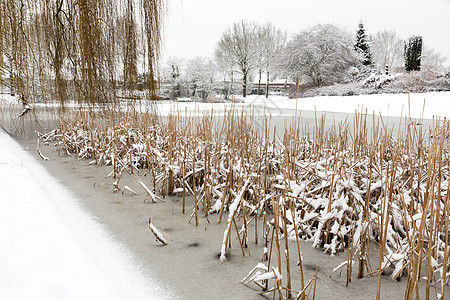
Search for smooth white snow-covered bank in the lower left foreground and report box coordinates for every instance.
[0,130,173,299]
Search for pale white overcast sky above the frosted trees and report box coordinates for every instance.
[162,0,450,65]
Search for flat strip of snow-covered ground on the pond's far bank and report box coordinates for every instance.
[157,92,450,119]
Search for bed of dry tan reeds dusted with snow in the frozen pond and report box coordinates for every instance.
[45,103,450,299]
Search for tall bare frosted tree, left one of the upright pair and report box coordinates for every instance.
[215,21,258,97]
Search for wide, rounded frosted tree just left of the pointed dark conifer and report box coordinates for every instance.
[277,24,361,86]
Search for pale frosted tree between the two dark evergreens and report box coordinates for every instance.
[371,30,405,73]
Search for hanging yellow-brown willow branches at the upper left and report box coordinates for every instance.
[0,0,164,104]
